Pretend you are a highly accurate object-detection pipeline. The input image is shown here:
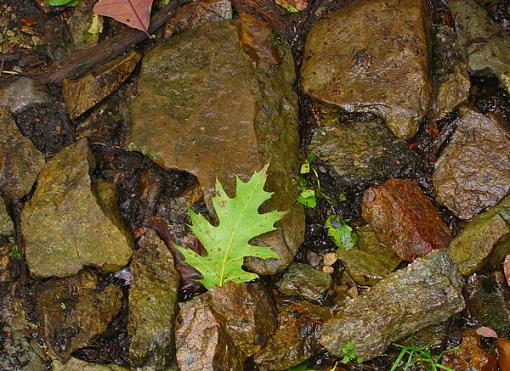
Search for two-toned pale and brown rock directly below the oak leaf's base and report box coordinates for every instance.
[175,284,276,370]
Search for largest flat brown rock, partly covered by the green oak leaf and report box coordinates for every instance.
[130,16,304,274]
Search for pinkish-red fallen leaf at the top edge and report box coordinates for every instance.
[94,0,153,33]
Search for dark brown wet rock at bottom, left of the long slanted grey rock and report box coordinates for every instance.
[253,299,331,371]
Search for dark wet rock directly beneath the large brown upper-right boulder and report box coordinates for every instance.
[308,120,419,188]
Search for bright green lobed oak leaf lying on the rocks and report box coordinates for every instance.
[177,165,285,289]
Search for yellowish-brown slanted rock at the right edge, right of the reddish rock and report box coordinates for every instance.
[446,196,510,276]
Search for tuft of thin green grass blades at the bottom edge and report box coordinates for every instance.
[390,344,458,371]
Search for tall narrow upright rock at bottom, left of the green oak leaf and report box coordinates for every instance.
[128,230,179,370]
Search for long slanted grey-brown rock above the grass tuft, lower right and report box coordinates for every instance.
[320,250,464,359]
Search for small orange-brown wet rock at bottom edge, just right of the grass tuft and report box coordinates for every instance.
[441,330,498,371]
